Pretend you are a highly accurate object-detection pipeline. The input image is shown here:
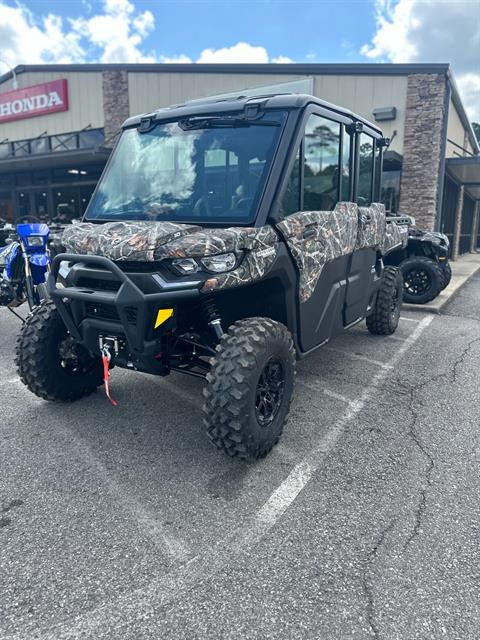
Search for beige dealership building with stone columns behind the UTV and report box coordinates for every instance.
[0,64,480,255]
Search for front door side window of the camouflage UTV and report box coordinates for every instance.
[303,115,341,211]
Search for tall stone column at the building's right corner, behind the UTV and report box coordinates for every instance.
[400,74,449,231]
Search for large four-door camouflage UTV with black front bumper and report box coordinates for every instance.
[17,95,408,459]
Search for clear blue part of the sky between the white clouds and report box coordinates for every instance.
[5,0,375,62]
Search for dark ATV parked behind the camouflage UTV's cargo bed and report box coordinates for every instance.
[386,226,452,304]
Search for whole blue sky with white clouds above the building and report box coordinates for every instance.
[0,0,480,121]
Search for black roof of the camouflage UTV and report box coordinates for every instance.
[123,93,382,136]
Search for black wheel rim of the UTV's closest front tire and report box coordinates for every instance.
[255,358,285,427]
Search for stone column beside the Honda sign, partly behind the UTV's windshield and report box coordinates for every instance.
[102,71,130,148]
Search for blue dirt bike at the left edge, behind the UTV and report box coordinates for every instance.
[0,223,50,313]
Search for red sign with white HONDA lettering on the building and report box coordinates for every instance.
[0,80,68,124]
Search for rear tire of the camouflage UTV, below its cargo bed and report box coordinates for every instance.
[367,266,403,336]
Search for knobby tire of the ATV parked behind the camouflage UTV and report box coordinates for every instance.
[400,256,444,304]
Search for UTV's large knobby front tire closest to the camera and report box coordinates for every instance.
[203,318,295,460]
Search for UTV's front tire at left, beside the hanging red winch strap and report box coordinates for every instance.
[15,300,103,402]
